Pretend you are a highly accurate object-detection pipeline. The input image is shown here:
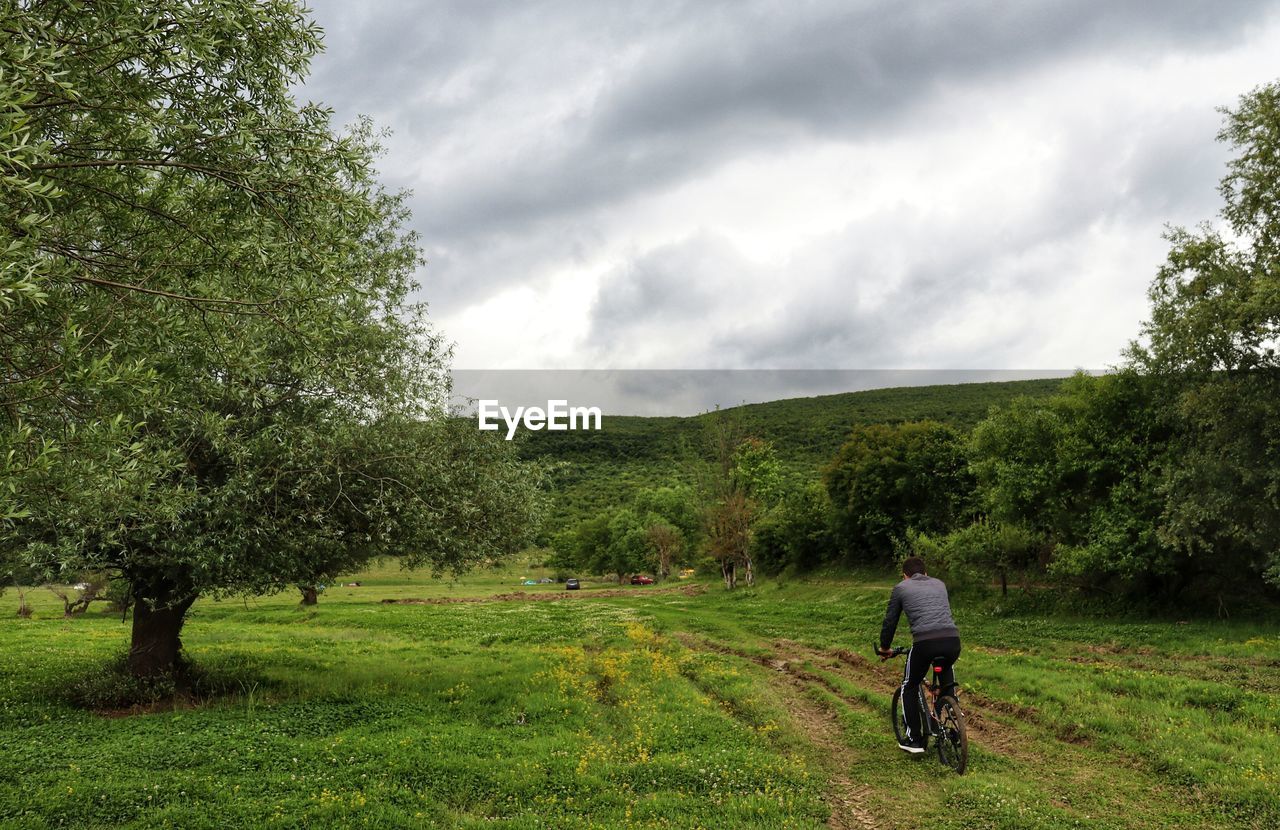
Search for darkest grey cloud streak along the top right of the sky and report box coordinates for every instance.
[595,0,1268,141]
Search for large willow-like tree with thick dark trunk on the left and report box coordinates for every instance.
[0,0,536,675]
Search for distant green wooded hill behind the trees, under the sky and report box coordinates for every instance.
[521,378,1062,535]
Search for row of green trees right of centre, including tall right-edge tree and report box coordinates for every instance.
[557,85,1280,611]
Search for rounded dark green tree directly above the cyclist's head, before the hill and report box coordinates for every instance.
[823,421,973,561]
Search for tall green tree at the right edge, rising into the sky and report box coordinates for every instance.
[1129,83,1280,587]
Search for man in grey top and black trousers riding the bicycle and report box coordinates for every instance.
[879,556,960,753]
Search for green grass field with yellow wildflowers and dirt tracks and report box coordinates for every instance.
[0,567,1280,829]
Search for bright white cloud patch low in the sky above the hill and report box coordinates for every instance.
[590,165,1151,370]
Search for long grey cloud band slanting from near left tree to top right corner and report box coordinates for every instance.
[396,0,1262,245]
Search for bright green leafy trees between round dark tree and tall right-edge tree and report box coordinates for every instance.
[970,371,1177,598]
